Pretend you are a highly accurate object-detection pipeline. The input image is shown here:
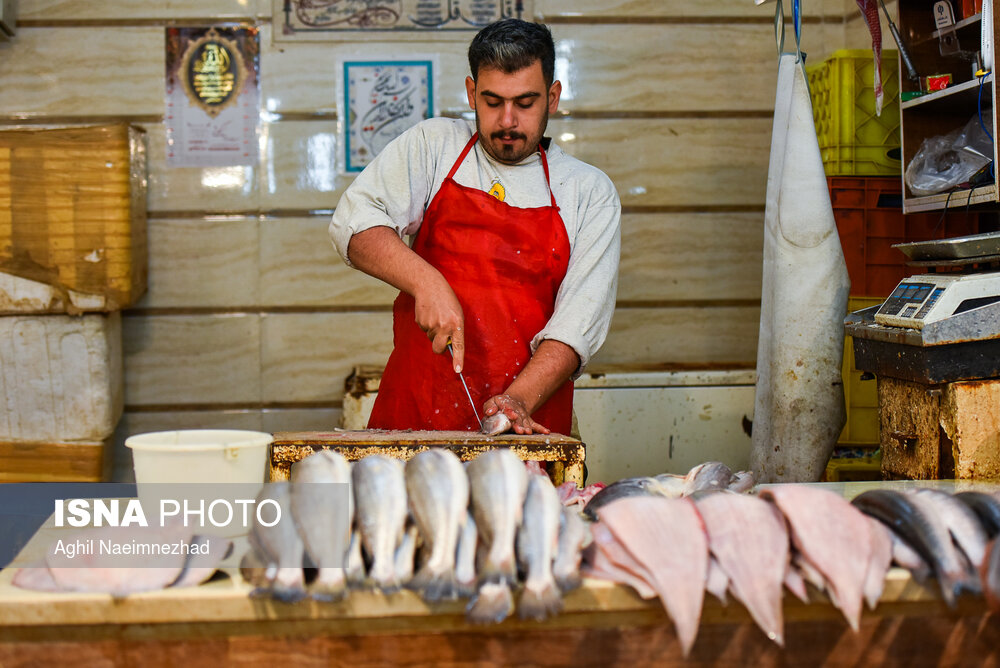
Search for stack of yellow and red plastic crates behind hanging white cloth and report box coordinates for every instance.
[807,49,979,480]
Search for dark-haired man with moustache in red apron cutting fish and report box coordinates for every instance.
[330,19,621,434]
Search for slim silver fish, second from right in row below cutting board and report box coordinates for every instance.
[517,475,562,621]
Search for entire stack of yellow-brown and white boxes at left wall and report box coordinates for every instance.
[0,124,147,481]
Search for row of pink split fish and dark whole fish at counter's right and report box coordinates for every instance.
[584,485,1000,654]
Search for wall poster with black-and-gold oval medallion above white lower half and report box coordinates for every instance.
[164,27,260,167]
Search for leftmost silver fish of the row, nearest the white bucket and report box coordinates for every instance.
[248,481,307,603]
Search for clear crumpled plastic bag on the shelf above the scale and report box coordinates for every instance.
[906,116,993,197]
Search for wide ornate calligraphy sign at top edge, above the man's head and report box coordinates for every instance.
[273,0,534,41]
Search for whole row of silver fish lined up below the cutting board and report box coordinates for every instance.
[242,449,590,623]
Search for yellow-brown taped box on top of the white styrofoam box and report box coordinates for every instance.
[0,124,147,314]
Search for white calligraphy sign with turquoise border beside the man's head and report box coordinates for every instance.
[338,57,437,172]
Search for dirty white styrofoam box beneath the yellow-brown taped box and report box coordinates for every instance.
[0,312,124,442]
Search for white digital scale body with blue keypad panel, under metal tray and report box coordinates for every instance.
[875,272,1000,329]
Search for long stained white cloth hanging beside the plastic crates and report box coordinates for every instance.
[750,54,850,482]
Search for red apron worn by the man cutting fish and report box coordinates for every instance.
[368,134,573,434]
